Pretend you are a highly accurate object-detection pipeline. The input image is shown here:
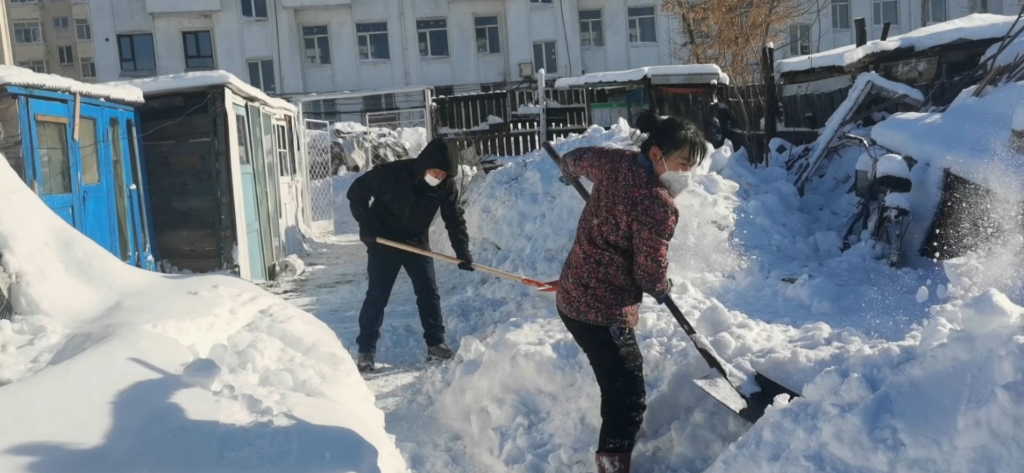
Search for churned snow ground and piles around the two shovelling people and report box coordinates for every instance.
[270,115,1024,472]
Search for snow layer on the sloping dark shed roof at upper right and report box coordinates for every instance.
[775,13,1017,75]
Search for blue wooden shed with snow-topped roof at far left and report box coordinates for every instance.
[0,67,155,270]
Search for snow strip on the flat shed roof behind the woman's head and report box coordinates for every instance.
[555,65,729,89]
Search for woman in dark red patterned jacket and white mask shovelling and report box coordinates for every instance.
[557,113,708,473]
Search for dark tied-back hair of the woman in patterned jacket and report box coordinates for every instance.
[634,111,708,166]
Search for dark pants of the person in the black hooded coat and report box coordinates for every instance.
[355,244,444,353]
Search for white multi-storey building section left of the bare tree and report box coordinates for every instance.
[89,0,680,94]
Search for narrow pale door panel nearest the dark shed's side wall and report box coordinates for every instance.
[234,105,266,282]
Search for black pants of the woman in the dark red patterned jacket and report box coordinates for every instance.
[558,312,647,454]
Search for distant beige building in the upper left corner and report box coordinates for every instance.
[4,0,96,82]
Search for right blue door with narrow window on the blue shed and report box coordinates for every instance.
[72,104,113,254]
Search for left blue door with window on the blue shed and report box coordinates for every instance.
[29,100,75,227]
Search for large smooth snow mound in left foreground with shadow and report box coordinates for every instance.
[0,157,406,473]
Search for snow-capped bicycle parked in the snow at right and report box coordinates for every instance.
[842,133,913,267]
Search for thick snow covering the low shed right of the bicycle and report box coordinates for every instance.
[871,83,1024,259]
